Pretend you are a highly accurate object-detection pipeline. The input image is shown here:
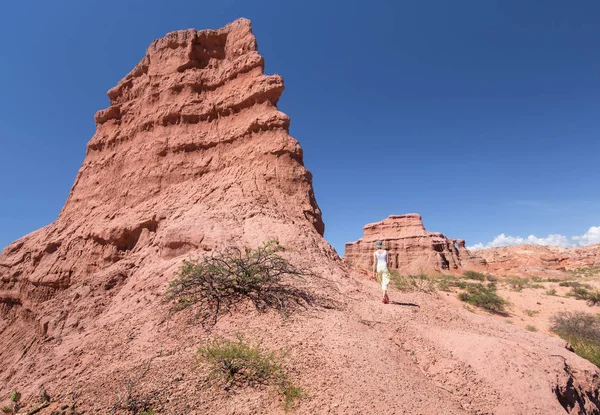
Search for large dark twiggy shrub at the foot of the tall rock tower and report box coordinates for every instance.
[165,241,314,324]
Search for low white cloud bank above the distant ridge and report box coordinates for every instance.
[467,226,600,251]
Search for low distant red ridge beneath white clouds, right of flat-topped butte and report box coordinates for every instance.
[473,244,600,277]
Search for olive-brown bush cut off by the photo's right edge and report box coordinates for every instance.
[551,311,600,367]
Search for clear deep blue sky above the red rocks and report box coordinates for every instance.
[0,0,600,254]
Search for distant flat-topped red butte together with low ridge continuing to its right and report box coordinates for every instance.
[344,213,600,278]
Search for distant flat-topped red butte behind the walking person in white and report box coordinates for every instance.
[344,213,485,273]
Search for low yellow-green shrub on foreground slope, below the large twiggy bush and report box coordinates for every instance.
[198,335,306,409]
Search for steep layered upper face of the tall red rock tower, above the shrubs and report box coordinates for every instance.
[0,20,327,309]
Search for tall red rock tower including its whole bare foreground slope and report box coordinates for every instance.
[0,19,600,415]
